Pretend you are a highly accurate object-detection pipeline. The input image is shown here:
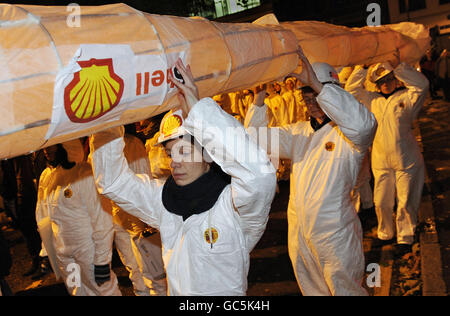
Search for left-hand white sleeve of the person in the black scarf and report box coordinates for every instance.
[90,127,164,228]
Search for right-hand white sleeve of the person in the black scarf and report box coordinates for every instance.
[184,98,276,251]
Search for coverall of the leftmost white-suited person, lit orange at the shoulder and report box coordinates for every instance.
[36,162,121,296]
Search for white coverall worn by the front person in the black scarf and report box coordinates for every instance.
[91,98,276,296]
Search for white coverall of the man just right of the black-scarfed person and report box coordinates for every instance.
[245,84,376,295]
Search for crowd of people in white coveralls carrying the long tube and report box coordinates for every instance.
[0,44,436,296]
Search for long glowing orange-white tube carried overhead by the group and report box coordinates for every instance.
[0,4,426,159]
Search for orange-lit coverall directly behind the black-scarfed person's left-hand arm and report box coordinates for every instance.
[112,134,167,296]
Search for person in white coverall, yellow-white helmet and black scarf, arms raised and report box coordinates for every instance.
[91,60,275,296]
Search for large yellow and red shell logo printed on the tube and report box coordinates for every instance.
[64,58,124,123]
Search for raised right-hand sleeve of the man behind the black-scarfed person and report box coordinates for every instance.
[317,84,377,152]
